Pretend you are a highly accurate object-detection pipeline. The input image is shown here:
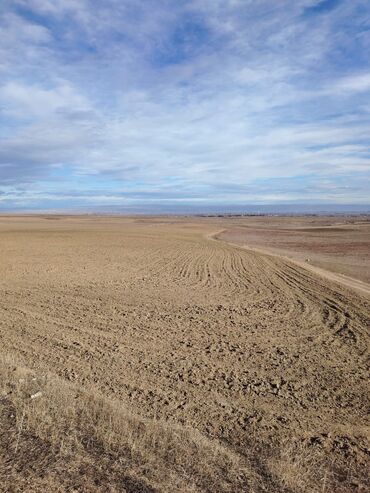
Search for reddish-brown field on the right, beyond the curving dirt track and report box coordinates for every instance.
[214,212,370,283]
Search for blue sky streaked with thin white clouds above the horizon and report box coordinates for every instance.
[0,0,370,211]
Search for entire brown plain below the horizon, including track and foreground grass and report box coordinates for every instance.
[0,215,370,493]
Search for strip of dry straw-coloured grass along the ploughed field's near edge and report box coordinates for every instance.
[0,358,366,493]
